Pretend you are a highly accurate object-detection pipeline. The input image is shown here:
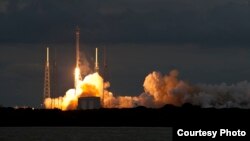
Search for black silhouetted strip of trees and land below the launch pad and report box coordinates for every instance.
[0,104,250,128]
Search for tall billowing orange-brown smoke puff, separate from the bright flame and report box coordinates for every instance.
[143,70,192,107]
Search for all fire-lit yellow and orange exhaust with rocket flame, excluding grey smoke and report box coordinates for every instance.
[44,63,186,110]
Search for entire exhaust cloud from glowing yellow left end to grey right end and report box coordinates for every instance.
[44,70,250,110]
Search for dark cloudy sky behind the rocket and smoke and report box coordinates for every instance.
[0,0,250,107]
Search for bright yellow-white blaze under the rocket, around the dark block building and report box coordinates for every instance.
[44,68,103,110]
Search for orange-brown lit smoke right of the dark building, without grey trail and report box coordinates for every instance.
[102,70,192,108]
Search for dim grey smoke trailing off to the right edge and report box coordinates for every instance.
[185,81,250,108]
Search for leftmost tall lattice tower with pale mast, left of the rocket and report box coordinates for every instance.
[43,47,50,100]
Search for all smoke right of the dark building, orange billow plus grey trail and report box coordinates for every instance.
[105,70,250,108]
